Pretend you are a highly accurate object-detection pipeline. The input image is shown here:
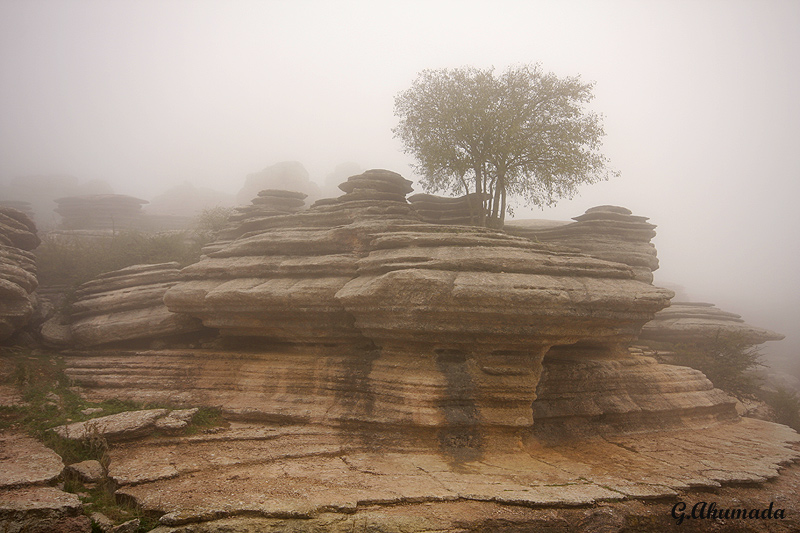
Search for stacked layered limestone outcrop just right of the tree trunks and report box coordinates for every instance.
[505,205,658,283]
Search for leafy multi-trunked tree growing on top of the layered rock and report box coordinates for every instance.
[393,64,616,226]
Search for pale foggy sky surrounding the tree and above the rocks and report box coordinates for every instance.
[0,0,800,374]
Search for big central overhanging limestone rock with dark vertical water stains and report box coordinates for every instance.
[158,170,672,447]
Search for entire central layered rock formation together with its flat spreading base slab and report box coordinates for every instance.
[3,170,800,532]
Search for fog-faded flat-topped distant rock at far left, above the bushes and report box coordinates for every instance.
[56,194,147,230]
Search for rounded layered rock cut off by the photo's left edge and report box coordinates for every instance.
[0,207,41,341]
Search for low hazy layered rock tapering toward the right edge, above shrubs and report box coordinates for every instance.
[639,302,784,346]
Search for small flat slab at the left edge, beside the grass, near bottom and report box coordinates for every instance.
[0,431,64,488]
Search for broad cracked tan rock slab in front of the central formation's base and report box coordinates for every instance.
[109,419,800,531]
